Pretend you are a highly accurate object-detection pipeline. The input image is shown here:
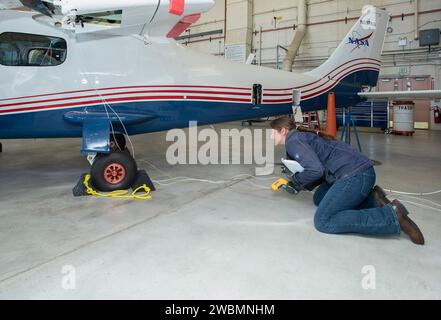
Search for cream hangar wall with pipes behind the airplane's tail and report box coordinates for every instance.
[180,0,441,88]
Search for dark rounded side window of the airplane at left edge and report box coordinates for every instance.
[0,32,67,67]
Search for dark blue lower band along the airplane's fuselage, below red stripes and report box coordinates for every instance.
[0,70,378,139]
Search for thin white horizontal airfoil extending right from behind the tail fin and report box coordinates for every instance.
[358,90,441,100]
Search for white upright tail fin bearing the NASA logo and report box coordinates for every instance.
[307,5,389,86]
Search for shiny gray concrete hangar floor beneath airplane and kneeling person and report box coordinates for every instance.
[0,124,441,299]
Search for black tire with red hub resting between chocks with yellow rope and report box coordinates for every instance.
[90,151,138,192]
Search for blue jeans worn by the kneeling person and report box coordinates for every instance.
[314,168,400,235]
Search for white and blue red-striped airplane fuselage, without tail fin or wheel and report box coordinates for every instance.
[0,11,380,139]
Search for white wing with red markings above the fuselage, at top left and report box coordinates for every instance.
[0,0,214,38]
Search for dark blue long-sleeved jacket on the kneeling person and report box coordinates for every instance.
[285,130,372,187]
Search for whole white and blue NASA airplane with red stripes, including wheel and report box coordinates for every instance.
[0,0,389,191]
